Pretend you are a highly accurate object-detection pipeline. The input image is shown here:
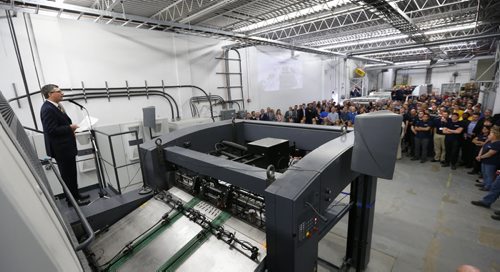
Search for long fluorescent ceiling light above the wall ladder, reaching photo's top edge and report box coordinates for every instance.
[234,0,351,32]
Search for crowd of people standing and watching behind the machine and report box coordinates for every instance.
[246,91,500,220]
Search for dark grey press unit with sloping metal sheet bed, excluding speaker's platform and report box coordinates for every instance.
[87,112,402,272]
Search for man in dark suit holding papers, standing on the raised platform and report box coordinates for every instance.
[40,84,90,206]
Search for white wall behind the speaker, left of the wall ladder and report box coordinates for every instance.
[0,16,229,127]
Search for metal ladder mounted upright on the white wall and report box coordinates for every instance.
[216,49,245,111]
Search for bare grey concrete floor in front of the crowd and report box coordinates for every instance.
[318,158,500,272]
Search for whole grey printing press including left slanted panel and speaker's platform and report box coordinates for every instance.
[0,92,402,272]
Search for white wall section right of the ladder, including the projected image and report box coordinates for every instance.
[238,46,360,112]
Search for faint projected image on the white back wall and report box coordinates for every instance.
[258,54,303,92]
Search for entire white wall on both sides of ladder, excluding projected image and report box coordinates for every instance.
[0,14,360,127]
